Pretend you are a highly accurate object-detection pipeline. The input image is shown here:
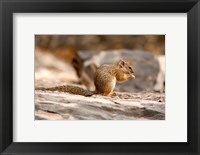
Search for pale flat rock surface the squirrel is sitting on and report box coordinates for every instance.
[35,90,165,120]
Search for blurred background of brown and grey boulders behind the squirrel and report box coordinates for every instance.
[35,35,165,92]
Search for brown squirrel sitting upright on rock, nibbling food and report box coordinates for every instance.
[36,59,135,96]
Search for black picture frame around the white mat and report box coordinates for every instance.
[0,0,200,155]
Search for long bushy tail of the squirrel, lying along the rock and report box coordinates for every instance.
[35,85,95,96]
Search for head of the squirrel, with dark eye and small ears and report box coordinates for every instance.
[117,59,135,79]
